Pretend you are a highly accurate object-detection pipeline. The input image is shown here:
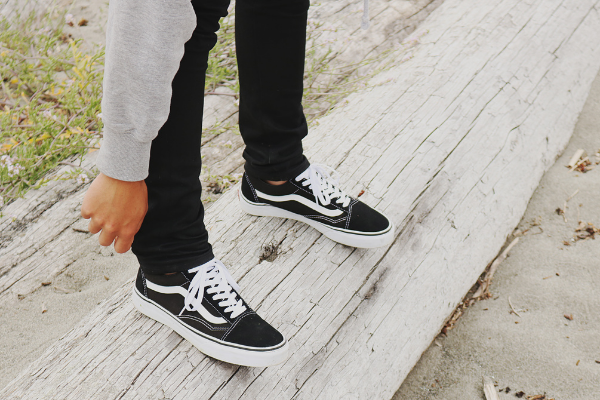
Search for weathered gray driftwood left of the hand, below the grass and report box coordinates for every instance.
[0,157,98,304]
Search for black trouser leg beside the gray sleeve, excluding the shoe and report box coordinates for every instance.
[132,0,229,274]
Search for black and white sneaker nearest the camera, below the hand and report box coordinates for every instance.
[133,258,288,367]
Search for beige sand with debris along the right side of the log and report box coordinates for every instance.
[394,70,600,400]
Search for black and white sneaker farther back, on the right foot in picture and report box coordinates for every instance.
[239,165,394,248]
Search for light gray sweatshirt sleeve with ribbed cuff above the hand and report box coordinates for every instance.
[96,0,196,181]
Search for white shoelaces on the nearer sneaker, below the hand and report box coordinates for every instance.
[181,258,246,318]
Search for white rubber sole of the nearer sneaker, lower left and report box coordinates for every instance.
[131,286,288,367]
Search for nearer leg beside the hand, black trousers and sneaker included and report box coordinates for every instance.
[132,0,288,367]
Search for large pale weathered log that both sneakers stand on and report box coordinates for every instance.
[0,0,600,399]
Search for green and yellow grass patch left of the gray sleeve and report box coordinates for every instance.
[0,10,104,202]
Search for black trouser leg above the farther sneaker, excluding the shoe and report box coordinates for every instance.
[235,0,310,180]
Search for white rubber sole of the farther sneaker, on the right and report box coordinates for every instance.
[238,190,395,249]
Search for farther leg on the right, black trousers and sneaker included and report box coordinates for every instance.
[236,0,394,247]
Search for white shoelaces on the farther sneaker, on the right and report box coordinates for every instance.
[296,164,352,207]
